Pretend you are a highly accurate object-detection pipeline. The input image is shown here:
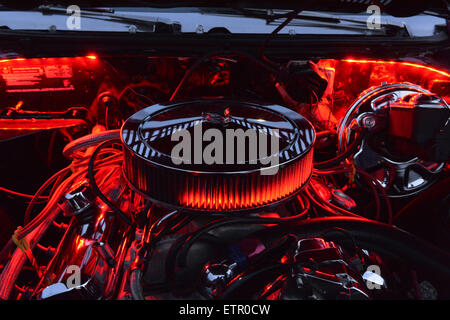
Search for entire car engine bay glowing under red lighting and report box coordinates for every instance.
[0,52,450,300]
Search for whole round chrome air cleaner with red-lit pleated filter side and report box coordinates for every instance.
[121,100,315,211]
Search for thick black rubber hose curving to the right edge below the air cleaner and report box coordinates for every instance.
[260,217,450,279]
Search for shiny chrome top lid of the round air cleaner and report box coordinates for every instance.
[122,100,315,174]
